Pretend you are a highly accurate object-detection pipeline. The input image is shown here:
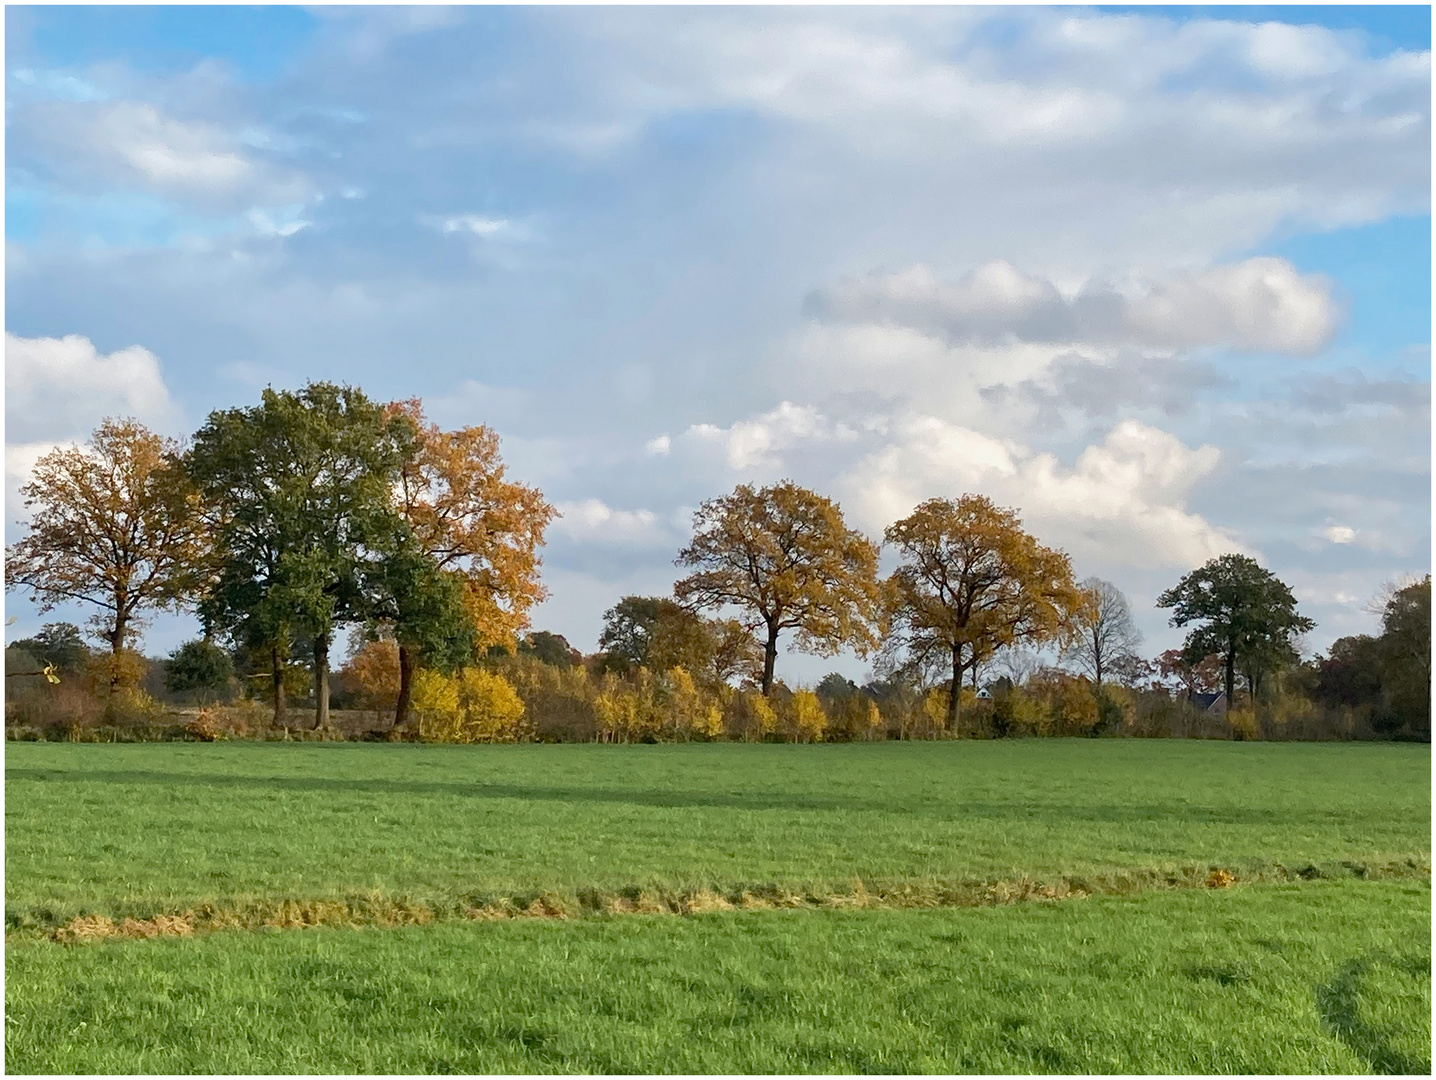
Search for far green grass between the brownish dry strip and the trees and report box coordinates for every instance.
[6,740,1430,929]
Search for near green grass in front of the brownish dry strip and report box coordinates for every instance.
[6,879,1430,1073]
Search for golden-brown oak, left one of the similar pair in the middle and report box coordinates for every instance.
[673,480,880,695]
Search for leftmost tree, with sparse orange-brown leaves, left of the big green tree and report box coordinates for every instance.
[6,419,210,686]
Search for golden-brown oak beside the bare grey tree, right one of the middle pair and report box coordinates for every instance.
[885,495,1083,730]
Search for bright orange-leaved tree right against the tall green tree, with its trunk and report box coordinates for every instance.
[391,399,556,727]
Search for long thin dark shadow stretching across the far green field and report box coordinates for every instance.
[6,768,1347,827]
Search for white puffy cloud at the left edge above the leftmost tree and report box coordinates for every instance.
[4,333,175,445]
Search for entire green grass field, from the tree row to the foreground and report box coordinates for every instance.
[6,740,1430,1073]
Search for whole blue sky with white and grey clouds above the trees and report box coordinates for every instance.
[6,6,1432,681]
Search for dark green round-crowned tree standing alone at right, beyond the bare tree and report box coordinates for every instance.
[1157,554,1315,704]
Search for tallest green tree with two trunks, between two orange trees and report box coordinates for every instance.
[187,382,415,728]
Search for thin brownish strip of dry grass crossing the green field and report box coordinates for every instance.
[16,859,1430,944]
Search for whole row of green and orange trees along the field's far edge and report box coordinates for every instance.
[6,382,1429,735]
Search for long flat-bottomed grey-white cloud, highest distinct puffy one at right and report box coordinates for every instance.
[807,259,1337,353]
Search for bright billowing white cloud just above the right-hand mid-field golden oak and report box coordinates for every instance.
[839,415,1242,569]
